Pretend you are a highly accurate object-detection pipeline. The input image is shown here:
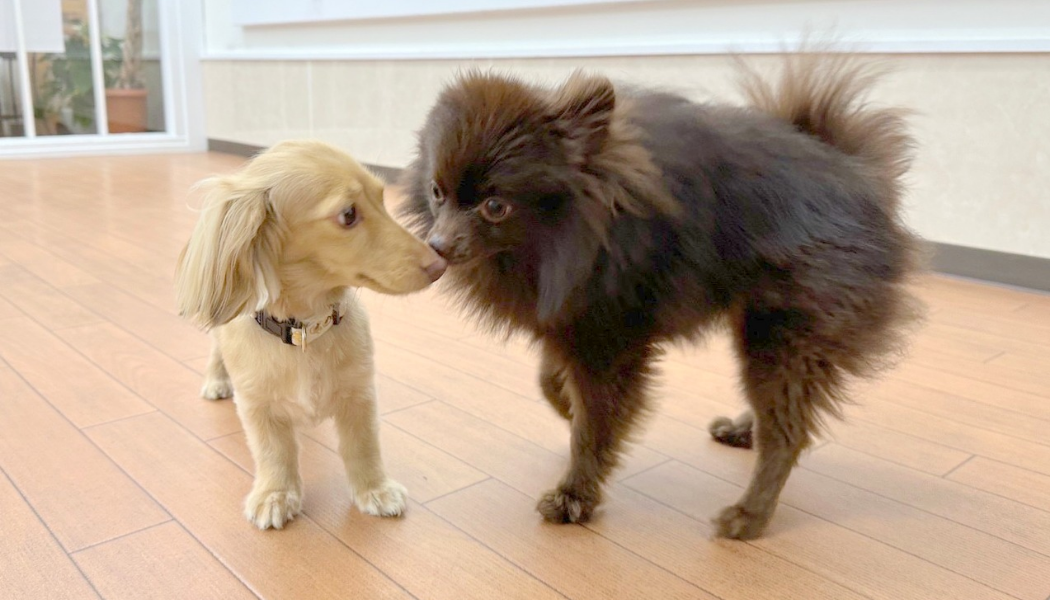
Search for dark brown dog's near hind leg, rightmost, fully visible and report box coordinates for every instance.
[716,310,841,539]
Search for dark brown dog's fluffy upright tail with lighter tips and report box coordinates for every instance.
[739,51,914,204]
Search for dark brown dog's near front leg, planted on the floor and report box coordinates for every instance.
[537,344,655,523]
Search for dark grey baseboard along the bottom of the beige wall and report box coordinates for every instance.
[208,138,1050,292]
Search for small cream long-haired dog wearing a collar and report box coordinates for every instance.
[175,142,445,529]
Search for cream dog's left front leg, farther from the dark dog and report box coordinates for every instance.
[236,399,302,530]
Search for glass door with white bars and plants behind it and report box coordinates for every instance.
[0,0,185,156]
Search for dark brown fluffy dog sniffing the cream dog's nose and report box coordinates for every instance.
[404,55,917,538]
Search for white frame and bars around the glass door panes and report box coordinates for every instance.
[0,0,207,159]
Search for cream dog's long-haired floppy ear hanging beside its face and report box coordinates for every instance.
[175,175,279,329]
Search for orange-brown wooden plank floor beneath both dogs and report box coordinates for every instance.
[0,154,1050,600]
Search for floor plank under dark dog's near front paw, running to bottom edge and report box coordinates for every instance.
[428,480,715,600]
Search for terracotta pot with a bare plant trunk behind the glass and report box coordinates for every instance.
[106,0,146,133]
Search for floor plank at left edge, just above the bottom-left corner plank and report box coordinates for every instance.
[0,364,170,551]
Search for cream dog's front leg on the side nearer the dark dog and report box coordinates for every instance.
[333,374,408,517]
